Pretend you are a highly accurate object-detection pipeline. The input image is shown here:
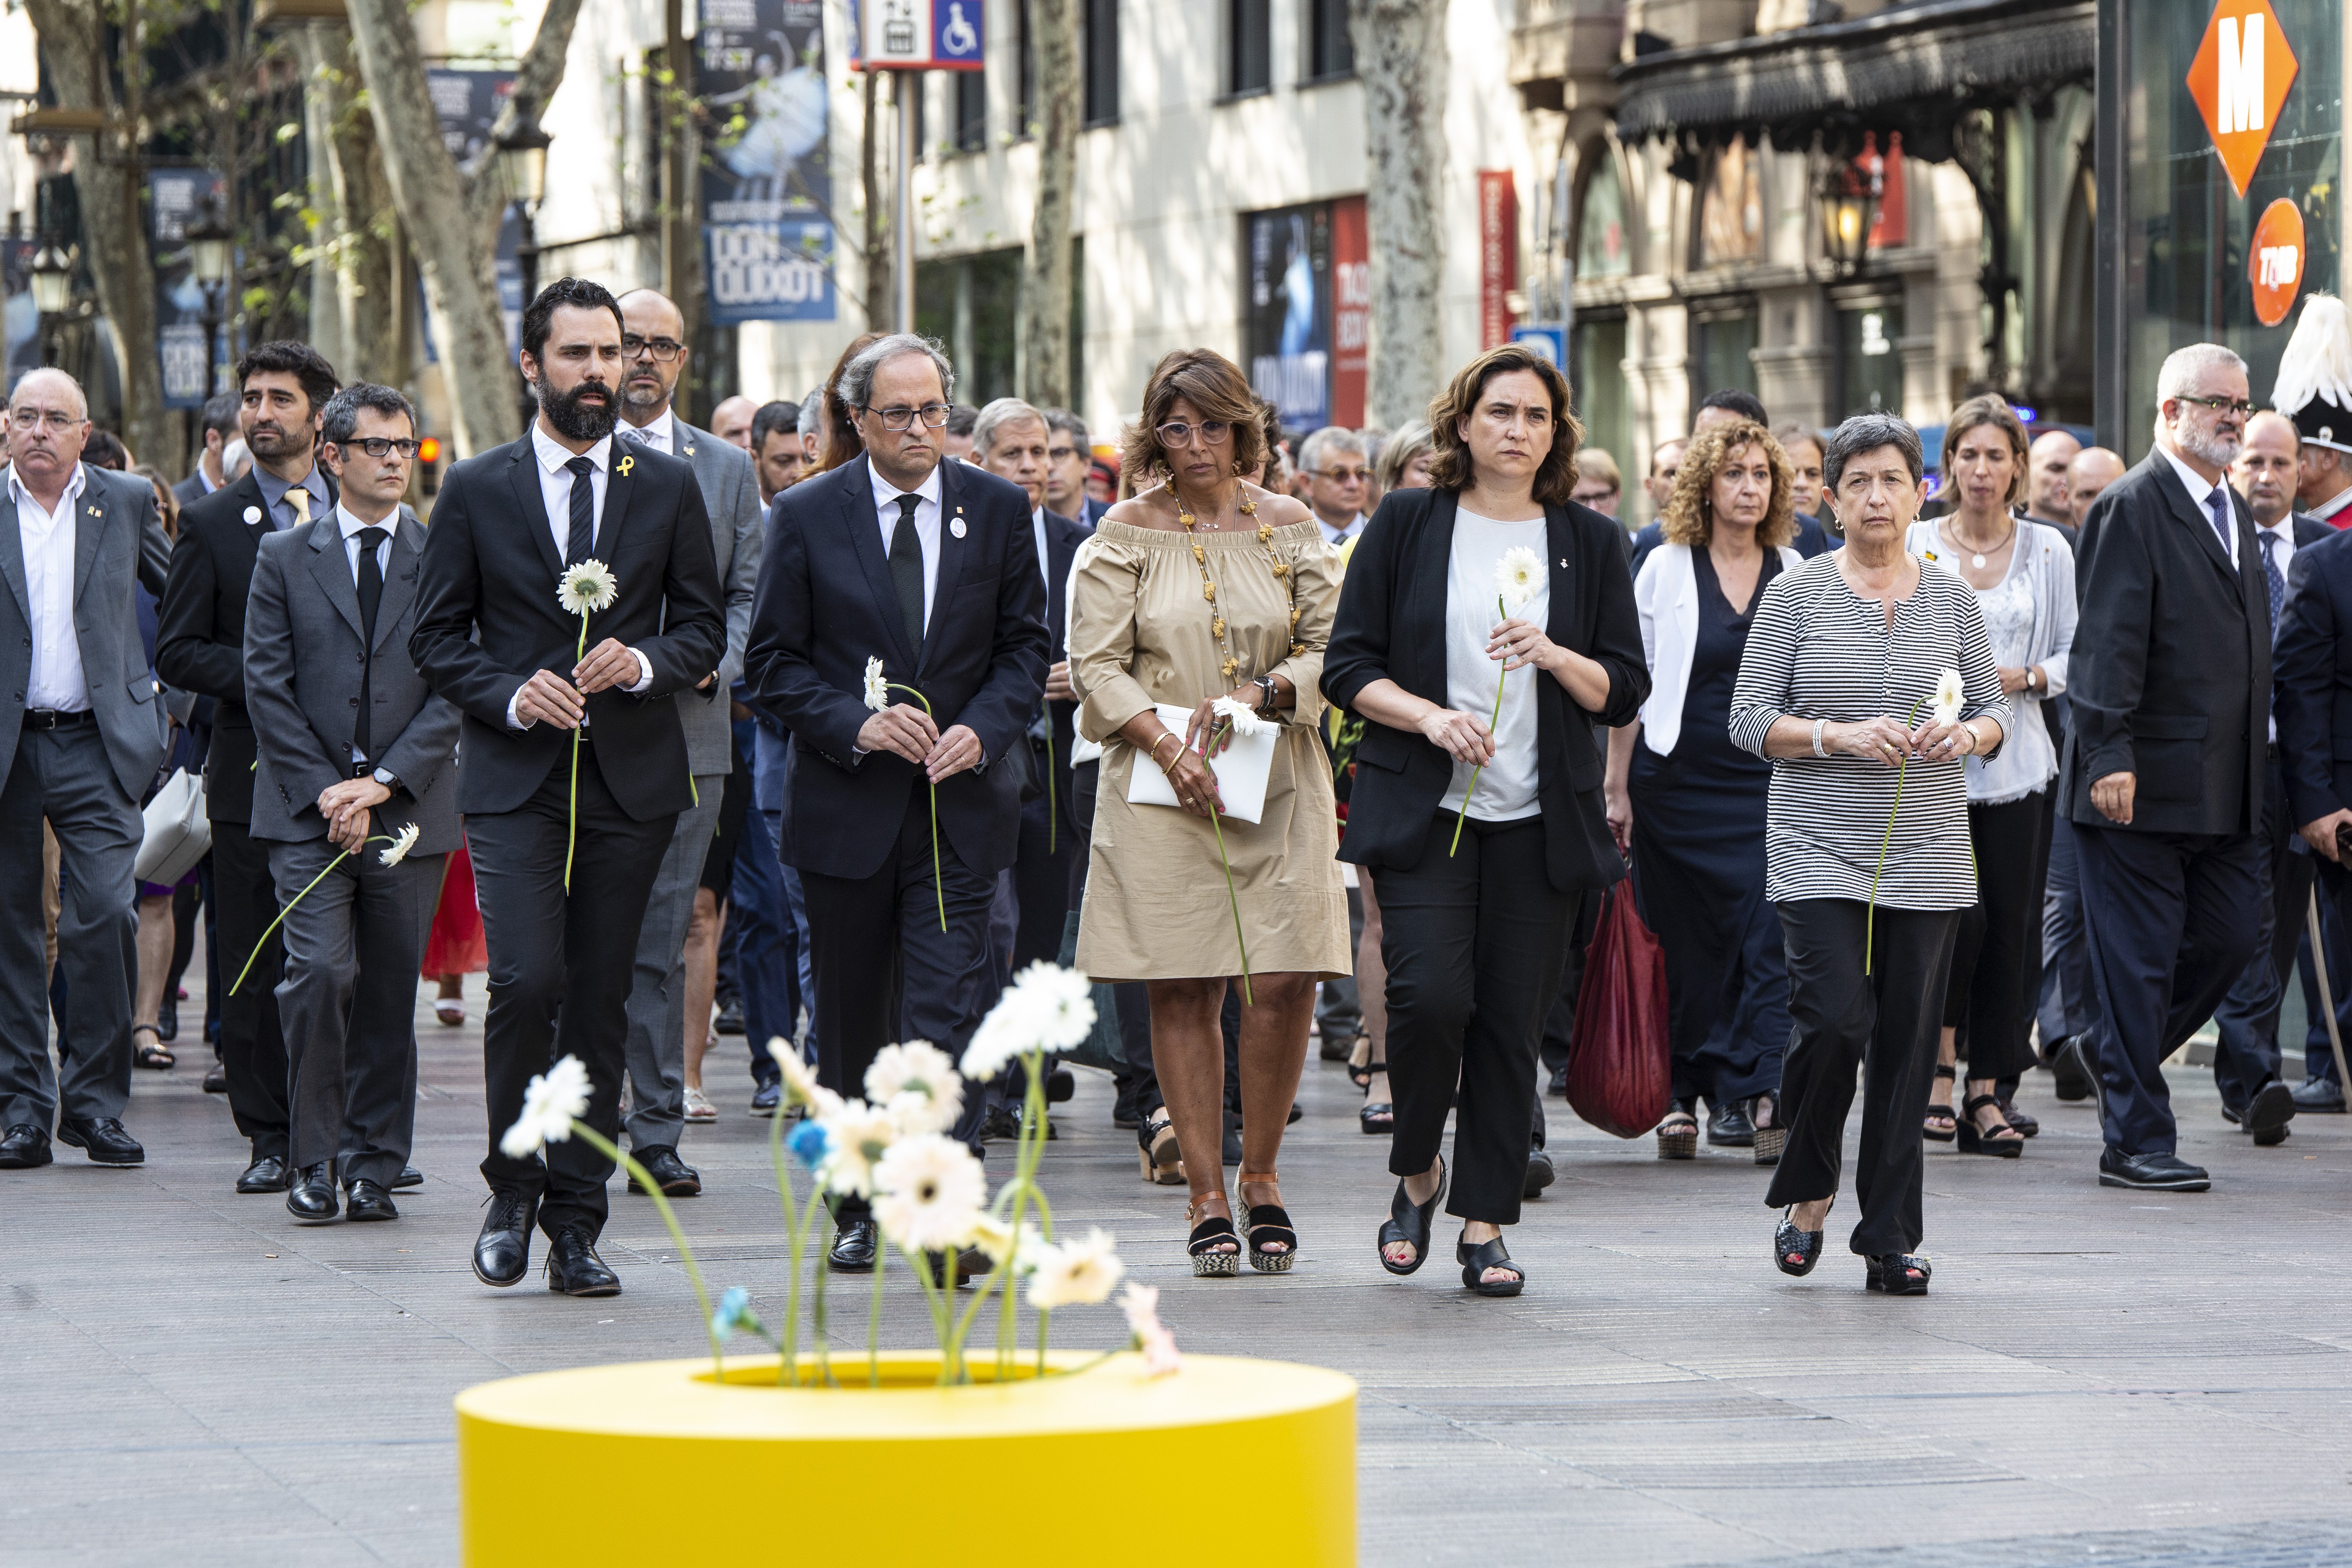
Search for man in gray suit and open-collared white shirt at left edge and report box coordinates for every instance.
[0,369,169,1171]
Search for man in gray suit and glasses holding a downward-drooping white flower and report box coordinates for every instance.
[245,383,459,1225]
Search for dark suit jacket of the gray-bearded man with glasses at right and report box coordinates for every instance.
[2058,451,2270,832]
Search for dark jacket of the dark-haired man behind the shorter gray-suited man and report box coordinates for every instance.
[155,468,336,823]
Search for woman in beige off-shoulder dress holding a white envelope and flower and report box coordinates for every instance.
[1070,348,1348,1274]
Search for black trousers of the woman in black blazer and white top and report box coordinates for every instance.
[1378,813,1585,1225]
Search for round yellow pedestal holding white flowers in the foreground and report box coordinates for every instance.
[456,1352,1355,1568]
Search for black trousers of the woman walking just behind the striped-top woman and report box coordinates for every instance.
[1943,790,2058,1079]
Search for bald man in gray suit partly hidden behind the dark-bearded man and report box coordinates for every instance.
[614,289,762,1196]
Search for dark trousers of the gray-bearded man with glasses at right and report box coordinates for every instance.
[2074,823,2267,1154]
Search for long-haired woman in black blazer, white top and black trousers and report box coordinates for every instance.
[1322,343,1649,1295]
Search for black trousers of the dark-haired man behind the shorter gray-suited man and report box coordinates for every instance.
[212,823,289,1159]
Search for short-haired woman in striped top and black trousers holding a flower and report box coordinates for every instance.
[1731,414,2009,1295]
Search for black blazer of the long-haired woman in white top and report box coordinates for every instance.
[1322,489,1649,893]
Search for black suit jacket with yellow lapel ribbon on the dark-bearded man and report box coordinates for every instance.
[409,435,727,823]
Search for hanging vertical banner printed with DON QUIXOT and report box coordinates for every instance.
[694,0,833,327]
